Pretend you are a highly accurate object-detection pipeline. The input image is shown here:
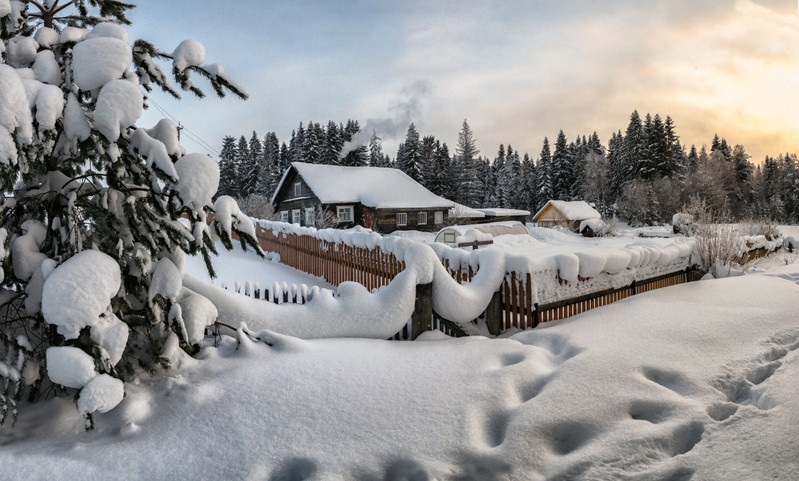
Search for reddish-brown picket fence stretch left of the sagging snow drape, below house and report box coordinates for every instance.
[255,226,405,291]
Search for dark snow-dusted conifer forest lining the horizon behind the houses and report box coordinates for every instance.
[219,111,799,225]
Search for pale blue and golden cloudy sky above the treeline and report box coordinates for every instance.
[130,0,799,162]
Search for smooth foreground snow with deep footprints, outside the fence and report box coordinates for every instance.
[0,232,799,481]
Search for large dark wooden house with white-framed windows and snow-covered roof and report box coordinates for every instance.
[272,162,455,233]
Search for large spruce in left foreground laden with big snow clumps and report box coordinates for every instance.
[0,0,258,428]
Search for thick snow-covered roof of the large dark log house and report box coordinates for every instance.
[273,162,455,209]
